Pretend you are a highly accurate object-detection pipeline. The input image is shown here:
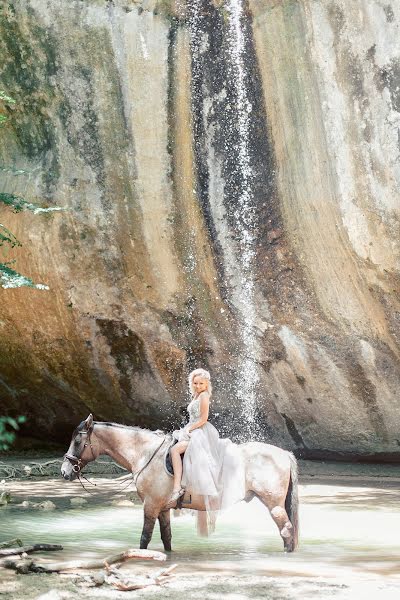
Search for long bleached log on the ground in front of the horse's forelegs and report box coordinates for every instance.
[19,549,167,573]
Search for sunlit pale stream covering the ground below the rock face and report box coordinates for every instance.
[0,466,400,600]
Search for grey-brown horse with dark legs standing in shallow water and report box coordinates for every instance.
[61,414,299,552]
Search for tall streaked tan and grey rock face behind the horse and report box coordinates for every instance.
[0,0,400,458]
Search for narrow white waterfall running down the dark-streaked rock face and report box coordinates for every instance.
[189,0,259,441]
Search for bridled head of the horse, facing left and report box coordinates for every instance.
[61,415,98,481]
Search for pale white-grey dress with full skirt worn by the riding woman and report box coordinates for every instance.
[182,392,245,535]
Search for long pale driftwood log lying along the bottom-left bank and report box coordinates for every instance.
[3,544,167,573]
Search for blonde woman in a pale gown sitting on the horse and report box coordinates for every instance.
[166,369,244,533]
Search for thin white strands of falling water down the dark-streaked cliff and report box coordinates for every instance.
[189,0,258,440]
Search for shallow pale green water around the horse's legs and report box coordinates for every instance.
[0,478,400,598]
